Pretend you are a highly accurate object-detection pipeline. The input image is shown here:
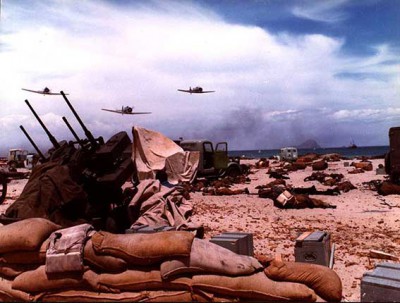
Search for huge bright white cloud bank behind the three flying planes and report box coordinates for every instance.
[0,1,399,152]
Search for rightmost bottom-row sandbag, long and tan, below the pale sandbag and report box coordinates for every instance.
[192,272,317,302]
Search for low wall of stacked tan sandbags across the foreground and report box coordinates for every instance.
[0,218,341,302]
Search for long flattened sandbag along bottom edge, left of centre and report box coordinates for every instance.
[35,290,197,302]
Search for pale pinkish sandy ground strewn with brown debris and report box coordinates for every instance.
[0,159,400,301]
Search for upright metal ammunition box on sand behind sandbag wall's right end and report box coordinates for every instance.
[294,231,331,266]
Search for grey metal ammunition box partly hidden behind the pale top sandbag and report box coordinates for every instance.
[210,232,254,256]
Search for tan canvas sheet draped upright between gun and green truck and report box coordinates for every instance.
[132,126,200,184]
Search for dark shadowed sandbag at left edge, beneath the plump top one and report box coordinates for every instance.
[0,238,49,264]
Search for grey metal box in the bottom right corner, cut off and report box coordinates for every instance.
[360,262,400,302]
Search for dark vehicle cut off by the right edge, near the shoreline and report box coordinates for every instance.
[385,127,400,183]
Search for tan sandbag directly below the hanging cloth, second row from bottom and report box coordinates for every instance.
[12,265,88,293]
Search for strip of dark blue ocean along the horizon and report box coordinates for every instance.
[229,146,389,159]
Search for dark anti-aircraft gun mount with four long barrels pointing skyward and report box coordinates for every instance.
[6,91,134,231]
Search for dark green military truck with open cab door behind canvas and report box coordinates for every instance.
[179,139,242,177]
